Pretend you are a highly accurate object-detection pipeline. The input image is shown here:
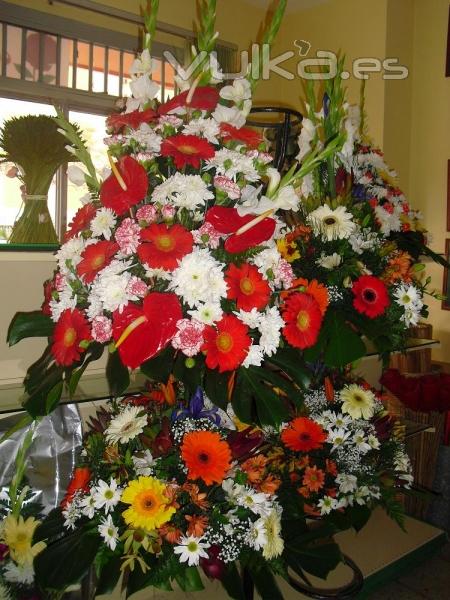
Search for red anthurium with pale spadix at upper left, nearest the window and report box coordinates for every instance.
[100,156,148,215]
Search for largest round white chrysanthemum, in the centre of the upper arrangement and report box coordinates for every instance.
[169,248,227,308]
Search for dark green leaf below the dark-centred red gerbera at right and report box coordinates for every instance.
[324,313,366,367]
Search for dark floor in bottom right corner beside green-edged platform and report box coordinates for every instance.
[368,543,450,600]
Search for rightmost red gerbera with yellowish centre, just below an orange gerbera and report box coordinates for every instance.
[281,292,322,349]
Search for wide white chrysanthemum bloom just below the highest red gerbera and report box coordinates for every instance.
[152,172,214,210]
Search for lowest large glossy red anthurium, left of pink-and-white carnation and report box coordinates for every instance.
[113,292,183,369]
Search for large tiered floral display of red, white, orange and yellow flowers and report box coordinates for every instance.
[2,0,446,598]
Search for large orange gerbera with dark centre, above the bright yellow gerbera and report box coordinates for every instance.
[181,431,231,485]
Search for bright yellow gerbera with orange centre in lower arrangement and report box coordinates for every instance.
[122,476,175,531]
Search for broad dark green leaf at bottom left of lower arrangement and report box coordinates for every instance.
[34,529,102,590]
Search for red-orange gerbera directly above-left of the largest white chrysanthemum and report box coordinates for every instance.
[137,223,194,271]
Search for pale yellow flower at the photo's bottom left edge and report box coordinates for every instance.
[2,515,46,565]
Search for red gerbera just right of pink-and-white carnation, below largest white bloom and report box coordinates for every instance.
[202,315,251,373]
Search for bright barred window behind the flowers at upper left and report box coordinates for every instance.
[0,0,179,243]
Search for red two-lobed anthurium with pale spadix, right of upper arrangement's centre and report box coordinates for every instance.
[205,206,276,254]
